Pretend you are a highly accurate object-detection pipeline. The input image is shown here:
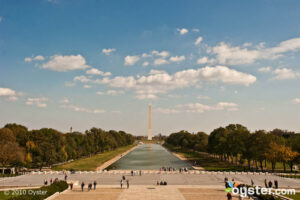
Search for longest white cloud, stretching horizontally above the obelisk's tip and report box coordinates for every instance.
[94,66,256,99]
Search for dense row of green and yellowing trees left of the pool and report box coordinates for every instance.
[0,124,134,168]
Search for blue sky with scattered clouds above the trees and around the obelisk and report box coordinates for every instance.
[0,0,300,135]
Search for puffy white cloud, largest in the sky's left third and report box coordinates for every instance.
[42,54,89,72]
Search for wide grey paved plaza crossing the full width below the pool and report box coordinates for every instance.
[0,172,300,188]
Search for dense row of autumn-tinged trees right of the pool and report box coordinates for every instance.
[165,124,300,171]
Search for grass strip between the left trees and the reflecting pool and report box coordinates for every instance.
[53,145,135,171]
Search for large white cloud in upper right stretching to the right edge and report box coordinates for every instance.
[208,38,300,65]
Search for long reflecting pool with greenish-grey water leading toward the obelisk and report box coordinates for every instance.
[108,144,191,170]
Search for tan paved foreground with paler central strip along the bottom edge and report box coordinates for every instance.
[54,185,230,200]
